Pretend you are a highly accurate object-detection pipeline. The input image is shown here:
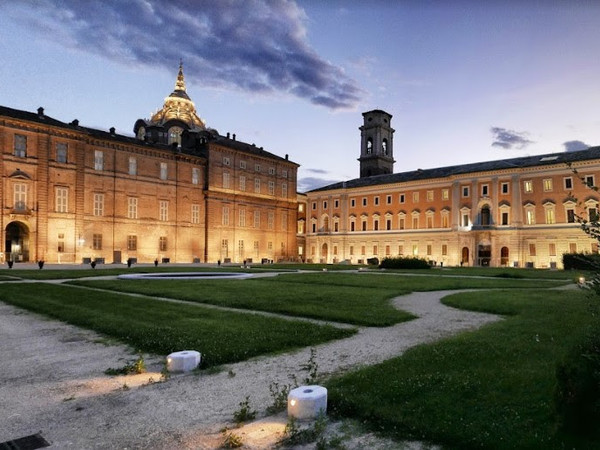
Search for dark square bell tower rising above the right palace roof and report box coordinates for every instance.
[358,109,395,178]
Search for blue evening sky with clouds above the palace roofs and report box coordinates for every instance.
[0,0,600,192]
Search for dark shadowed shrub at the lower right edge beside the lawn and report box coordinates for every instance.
[555,326,600,437]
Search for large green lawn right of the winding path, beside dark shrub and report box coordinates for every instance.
[327,291,600,449]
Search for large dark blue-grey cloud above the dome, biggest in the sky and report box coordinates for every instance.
[7,0,364,109]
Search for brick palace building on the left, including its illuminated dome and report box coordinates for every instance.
[0,65,298,263]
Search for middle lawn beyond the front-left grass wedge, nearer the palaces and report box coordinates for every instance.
[73,272,562,327]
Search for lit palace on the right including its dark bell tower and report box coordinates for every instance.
[298,110,600,268]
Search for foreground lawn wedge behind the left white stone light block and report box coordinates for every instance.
[0,283,355,367]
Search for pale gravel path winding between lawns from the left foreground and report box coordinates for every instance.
[0,291,499,449]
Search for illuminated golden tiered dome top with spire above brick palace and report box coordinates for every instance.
[150,62,206,130]
